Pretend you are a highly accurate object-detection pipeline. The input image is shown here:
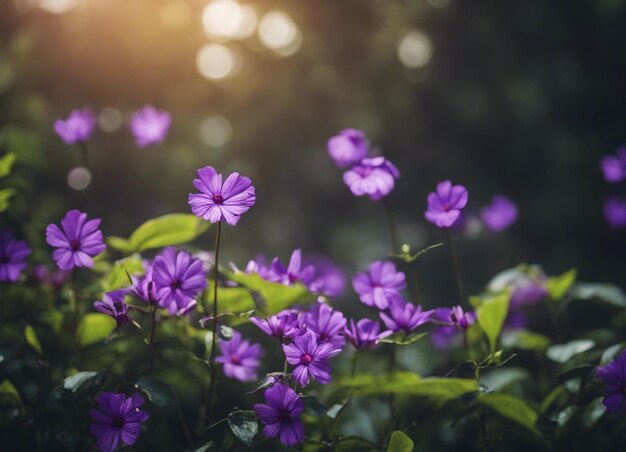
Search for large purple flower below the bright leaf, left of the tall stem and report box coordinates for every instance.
[152,247,207,315]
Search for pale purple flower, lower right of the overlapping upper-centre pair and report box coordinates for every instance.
[343,157,400,201]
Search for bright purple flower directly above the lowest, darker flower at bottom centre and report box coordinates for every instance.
[283,331,340,386]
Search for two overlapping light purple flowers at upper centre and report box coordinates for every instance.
[328,129,400,201]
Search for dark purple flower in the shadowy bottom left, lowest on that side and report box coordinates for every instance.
[89,392,150,452]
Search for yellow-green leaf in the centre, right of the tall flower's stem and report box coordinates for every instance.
[225,271,311,315]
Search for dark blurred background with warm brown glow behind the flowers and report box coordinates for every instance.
[0,0,626,305]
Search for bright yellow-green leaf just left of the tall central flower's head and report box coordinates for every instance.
[124,213,210,253]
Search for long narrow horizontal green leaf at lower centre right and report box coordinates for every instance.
[339,372,478,402]
